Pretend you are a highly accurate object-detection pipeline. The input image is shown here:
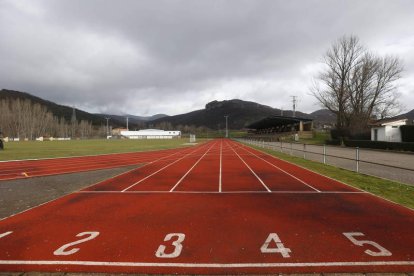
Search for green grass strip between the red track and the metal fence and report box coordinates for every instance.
[246,144,414,209]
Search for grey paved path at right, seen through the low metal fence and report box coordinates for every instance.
[239,139,414,185]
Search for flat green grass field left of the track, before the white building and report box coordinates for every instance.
[0,139,202,161]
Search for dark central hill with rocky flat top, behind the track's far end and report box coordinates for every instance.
[148,99,310,129]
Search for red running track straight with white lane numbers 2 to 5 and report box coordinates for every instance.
[0,140,414,274]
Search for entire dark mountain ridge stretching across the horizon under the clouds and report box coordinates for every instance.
[0,89,335,130]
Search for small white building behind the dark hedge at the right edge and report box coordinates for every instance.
[371,119,413,142]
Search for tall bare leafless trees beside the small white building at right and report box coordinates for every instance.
[312,36,403,135]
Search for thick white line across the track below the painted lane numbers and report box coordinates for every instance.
[0,260,414,268]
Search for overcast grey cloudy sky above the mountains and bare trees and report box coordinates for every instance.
[0,0,414,115]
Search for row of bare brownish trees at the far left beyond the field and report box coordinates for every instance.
[0,99,95,140]
